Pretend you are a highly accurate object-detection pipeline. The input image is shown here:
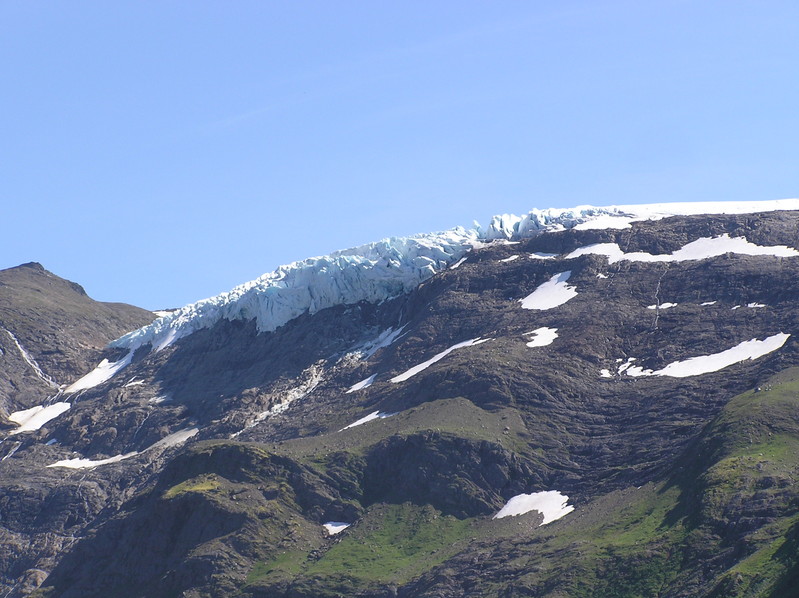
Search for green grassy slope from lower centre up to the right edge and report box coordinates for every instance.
[250,369,799,597]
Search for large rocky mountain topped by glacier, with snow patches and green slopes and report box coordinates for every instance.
[0,200,799,598]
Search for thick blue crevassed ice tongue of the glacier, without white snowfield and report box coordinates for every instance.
[111,228,478,351]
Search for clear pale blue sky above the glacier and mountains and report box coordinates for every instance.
[0,0,799,309]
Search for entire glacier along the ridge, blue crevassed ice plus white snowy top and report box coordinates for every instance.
[110,199,799,352]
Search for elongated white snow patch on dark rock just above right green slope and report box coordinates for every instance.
[619,332,791,378]
